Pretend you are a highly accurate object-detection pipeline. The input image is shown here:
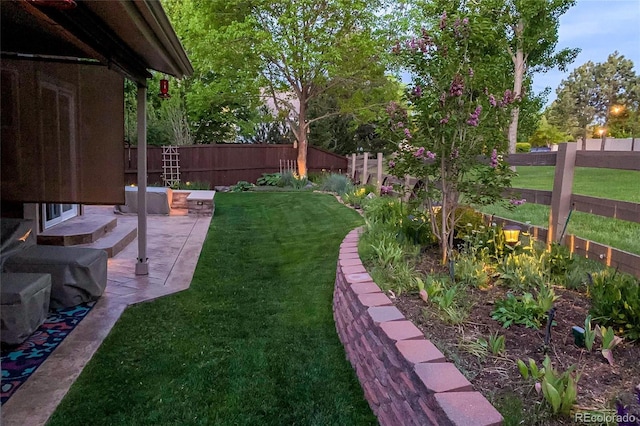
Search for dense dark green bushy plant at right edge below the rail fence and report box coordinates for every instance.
[587,269,640,341]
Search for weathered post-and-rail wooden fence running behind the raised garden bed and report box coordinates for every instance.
[349,143,640,278]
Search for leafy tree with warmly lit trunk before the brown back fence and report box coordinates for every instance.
[172,0,386,176]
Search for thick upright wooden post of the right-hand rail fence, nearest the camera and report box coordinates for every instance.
[547,142,577,244]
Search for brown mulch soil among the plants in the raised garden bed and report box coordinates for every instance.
[394,251,640,425]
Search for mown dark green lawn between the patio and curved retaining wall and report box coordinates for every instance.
[50,193,377,425]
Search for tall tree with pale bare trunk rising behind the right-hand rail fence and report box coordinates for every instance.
[478,0,579,153]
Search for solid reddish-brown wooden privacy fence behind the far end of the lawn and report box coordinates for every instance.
[124,144,347,187]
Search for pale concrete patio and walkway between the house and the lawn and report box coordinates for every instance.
[0,206,211,426]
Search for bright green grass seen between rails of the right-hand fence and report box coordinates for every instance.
[481,166,640,254]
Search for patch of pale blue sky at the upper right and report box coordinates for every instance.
[533,0,640,104]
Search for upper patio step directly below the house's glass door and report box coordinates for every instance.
[38,215,118,246]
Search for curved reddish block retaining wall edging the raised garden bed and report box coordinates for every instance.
[333,228,503,426]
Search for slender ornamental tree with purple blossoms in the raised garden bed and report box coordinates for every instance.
[387,8,516,263]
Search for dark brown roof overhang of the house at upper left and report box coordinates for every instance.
[0,0,193,83]
